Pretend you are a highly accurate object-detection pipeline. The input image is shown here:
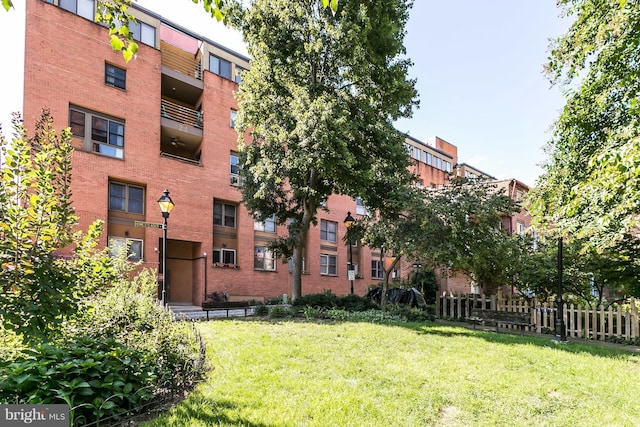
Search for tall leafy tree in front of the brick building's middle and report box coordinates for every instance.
[236,0,417,299]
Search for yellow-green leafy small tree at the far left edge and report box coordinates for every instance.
[0,110,111,340]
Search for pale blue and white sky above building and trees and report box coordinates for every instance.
[0,0,570,186]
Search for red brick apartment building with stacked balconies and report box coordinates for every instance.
[24,0,528,304]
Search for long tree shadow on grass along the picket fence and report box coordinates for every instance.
[404,322,640,359]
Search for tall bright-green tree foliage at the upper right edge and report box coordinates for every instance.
[530,0,640,250]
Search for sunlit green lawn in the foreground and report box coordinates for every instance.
[144,320,640,427]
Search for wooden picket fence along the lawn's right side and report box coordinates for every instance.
[436,294,640,341]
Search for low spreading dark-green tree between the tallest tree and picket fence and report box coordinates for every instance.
[358,177,522,302]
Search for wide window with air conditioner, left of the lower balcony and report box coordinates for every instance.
[69,107,124,159]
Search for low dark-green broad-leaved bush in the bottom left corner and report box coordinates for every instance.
[0,337,157,425]
